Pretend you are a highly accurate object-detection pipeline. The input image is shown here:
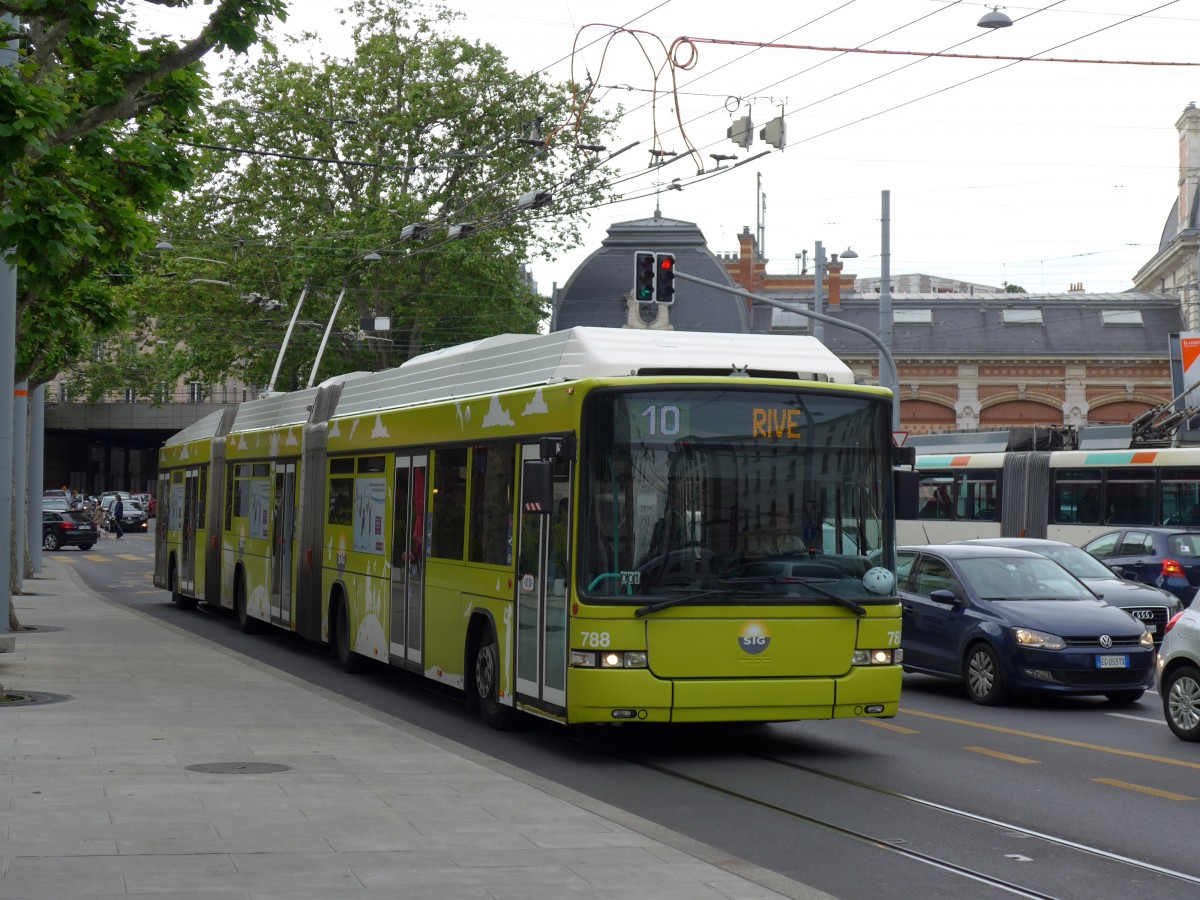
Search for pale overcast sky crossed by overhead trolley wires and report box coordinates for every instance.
[136,0,1200,294]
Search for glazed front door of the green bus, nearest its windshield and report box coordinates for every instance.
[516,444,571,712]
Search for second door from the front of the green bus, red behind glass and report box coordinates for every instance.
[388,456,428,672]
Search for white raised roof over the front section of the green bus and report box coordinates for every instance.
[335,326,854,416]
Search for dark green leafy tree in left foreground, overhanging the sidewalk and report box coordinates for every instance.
[0,0,286,626]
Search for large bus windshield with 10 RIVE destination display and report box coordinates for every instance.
[577,388,894,602]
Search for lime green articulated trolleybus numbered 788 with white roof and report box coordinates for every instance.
[155,328,901,727]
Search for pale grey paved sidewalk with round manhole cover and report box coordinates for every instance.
[0,554,826,900]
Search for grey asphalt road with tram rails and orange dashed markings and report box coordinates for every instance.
[44,533,1200,900]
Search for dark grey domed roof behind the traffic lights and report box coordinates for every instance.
[551,215,750,334]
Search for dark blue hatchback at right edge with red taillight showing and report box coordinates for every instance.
[1084,526,1200,606]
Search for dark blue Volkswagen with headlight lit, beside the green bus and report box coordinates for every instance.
[896,544,1154,706]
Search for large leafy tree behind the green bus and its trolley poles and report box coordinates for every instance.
[92,0,607,394]
